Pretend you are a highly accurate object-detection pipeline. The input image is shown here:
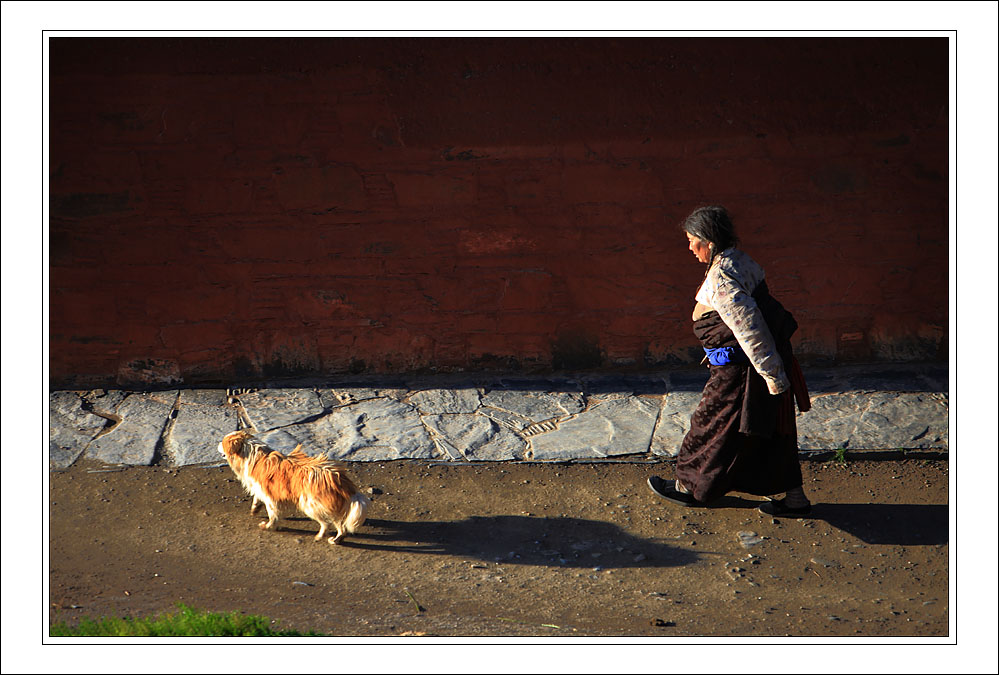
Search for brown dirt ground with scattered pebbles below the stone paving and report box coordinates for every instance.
[49,459,950,638]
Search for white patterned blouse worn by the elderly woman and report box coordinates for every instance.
[697,248,791,394]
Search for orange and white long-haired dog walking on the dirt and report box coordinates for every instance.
[219,430,371,544]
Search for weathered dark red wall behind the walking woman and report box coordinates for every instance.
[49,37,949,386]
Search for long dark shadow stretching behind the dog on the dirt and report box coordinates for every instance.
[316,516,700,569]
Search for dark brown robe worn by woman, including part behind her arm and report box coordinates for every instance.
[676,282,809,502]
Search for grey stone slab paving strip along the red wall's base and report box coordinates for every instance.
[49,364,949,470]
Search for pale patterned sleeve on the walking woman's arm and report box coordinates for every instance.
[706,268,791,394]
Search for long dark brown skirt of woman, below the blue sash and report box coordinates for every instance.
[676,365,801,502]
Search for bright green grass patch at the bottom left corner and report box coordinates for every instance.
[49,604,322,637]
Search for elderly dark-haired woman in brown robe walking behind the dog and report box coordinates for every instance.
[648,206,811,516]
